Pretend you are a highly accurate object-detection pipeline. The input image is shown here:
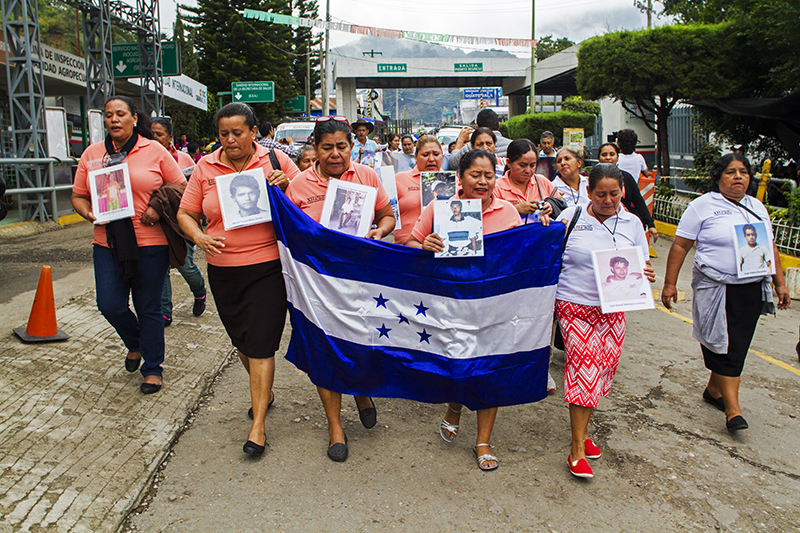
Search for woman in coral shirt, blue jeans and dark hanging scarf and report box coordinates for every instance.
[72,96,186,394]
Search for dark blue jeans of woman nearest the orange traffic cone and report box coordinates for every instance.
[94,244,169,376]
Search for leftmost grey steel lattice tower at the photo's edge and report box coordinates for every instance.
[2,0,47,220]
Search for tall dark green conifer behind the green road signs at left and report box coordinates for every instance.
[181,0,300,121]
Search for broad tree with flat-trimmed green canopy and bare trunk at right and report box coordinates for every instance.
[577,24,747,175]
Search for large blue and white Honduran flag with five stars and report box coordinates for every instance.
[268,187,564,410]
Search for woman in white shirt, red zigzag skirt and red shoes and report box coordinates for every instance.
[556,163,655,478]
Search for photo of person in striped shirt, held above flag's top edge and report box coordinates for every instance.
[433,200,483,257]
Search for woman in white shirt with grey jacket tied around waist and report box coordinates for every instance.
[661,153,789,431]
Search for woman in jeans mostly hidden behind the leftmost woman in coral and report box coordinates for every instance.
[147,117,206,326]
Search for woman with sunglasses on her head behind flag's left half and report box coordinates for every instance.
[286,116,395,462]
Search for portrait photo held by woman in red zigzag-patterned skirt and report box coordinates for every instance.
[592,247,655,313]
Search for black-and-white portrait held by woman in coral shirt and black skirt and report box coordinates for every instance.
[216,168,272,231]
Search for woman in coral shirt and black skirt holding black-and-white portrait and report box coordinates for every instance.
[178,103,300,456]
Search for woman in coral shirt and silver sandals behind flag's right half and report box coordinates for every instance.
[406,149,522,470]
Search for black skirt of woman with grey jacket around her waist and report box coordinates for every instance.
[700,281,761,378]
